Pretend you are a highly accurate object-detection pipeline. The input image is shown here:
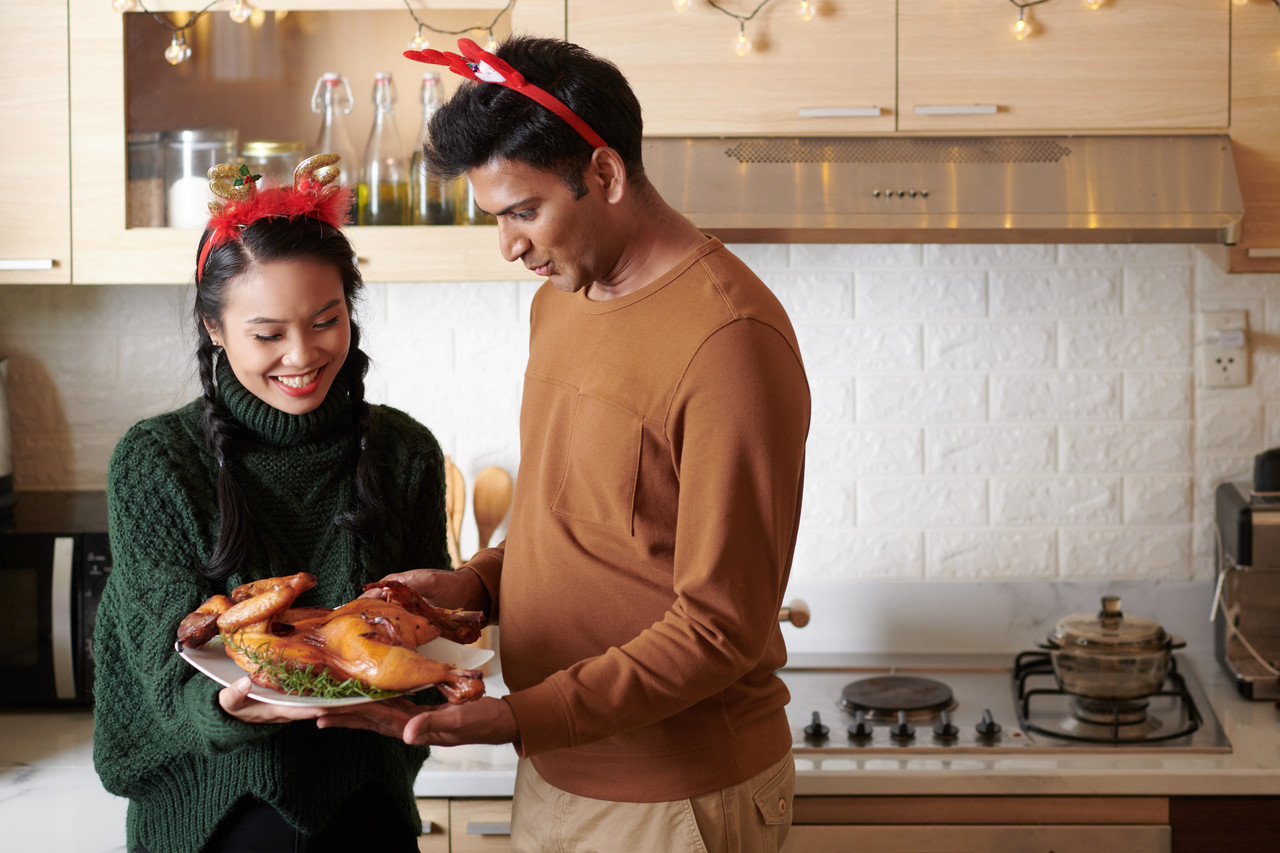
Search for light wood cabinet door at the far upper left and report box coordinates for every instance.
[0,0,72,284]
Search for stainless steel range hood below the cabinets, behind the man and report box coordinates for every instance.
[644,136,1244,245]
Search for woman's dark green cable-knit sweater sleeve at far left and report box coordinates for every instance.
[93,423,279,797]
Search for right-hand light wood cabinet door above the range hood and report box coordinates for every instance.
[897,0,1233,132]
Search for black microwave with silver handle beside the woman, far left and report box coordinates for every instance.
[0,492,111,706]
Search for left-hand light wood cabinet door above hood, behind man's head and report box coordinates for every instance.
[566,0,896,136]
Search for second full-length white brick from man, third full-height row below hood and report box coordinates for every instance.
[991,373,1123,423]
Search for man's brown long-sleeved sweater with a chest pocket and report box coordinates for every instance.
[471,240,809,802]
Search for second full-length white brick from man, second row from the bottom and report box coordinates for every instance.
[991,476,1124,528]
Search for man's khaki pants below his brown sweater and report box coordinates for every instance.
[511,752,796,853]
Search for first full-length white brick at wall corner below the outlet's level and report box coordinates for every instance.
[1059,424,1192,473]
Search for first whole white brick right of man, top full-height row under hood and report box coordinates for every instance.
[855,270,987,320]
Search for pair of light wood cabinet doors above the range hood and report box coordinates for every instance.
[566,0,1230,136]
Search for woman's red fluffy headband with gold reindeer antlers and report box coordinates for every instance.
[196,154,351,283]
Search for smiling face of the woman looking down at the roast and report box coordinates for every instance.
[205,260,351,415]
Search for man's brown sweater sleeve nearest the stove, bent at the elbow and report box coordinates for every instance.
[507,320,810,756]
